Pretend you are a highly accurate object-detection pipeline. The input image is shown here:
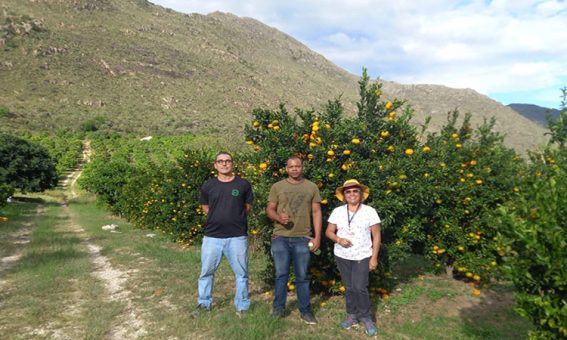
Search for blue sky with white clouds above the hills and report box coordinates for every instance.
[150,0,567,108]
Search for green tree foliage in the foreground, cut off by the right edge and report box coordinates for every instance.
[500,148,567,339]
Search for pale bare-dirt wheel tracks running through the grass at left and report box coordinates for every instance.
[0,141,147,339]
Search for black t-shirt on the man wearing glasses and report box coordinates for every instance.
[199,176,253,238]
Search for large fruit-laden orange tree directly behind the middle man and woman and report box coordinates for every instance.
[244,71,523,292]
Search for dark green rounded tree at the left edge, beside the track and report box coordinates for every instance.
[0,134,57,193]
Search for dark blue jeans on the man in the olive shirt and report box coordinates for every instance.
[272,236,312,314]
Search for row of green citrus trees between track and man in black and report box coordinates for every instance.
[79,133,213,245]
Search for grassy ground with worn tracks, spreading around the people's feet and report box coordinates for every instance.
[0,192,531,339]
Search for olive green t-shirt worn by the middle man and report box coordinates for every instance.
[268,179,321,237]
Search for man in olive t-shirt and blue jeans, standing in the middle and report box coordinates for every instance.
[266,157,323,324]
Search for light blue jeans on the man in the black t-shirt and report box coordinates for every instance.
[198,236,250,311]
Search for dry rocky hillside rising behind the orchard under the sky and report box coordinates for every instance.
[0,0,545,151]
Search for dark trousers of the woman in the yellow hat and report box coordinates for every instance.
[335,256,371,321]
